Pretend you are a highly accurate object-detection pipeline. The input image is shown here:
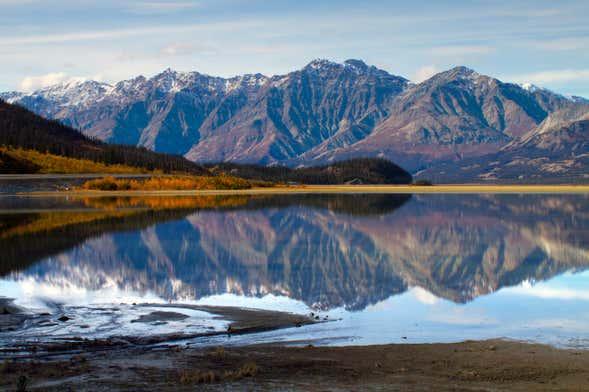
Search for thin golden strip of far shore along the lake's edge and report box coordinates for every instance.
[6,184,589,197]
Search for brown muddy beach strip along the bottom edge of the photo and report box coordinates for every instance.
[0,340,589,391]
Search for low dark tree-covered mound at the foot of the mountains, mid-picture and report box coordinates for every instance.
[207,158,412,185]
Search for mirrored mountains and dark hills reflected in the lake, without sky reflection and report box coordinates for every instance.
[0,194,589,310]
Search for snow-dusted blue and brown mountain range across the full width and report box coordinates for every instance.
[0,60,589,182]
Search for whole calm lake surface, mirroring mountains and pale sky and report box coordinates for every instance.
[0,194,589,348]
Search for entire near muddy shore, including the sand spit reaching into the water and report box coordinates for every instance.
[0,298,589,391]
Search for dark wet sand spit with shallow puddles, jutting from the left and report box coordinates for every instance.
[0,298,316,356]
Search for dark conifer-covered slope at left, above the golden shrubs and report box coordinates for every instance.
[0,100,207,175]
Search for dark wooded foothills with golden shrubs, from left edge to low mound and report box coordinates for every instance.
[0,99,412,183]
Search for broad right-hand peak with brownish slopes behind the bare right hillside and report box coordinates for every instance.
[307,67,577,170]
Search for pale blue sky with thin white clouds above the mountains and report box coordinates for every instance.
[0,0,589,97]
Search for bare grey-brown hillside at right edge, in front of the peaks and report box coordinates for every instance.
[416,105,589,184]
